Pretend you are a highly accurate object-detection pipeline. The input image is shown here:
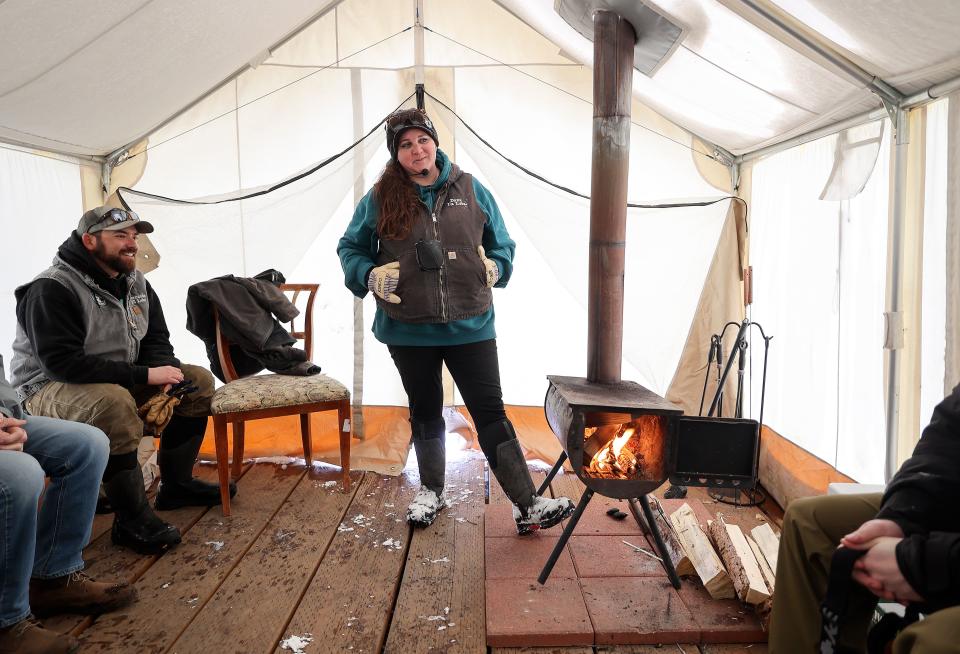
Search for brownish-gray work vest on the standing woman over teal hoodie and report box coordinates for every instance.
[376,165,493,323]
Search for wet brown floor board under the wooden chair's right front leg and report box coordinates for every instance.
[170,468,364,654]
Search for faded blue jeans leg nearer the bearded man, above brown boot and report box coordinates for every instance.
[23,416,110,579]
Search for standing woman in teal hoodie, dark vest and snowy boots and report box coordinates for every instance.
[337,109,574,534]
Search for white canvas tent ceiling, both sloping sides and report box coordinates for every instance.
[0,0,960,155]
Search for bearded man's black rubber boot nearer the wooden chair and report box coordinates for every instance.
[154,415,237,511]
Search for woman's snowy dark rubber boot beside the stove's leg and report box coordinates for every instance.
[478,420,576,535]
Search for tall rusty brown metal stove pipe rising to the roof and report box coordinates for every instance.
[587,10,636,384]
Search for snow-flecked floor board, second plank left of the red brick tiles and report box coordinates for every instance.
[277,474,419,654]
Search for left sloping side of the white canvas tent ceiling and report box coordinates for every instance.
[0,0,335,155]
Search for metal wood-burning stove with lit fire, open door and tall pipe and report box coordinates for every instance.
[538,3,759,588]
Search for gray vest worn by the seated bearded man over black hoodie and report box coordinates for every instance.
[10,256,150,400]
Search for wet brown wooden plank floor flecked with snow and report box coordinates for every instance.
[54,456,781,654]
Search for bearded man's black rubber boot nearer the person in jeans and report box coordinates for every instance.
[104,466,180,554]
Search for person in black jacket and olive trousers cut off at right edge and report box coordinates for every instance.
[770,386,960,654]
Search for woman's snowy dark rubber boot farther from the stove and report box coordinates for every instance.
[407,417,447,527]
